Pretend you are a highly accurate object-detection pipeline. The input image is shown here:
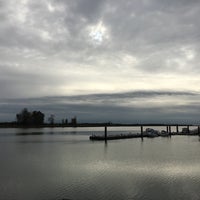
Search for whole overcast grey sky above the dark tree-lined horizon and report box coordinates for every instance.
[0,0,200,123]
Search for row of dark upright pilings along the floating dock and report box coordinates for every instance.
[104,125,200,140]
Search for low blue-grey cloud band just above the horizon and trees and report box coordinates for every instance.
[0,91,200,123]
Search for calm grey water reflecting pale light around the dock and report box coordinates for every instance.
[0,127,200,200]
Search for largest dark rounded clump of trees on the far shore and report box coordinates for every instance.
[16,108,45,125]
